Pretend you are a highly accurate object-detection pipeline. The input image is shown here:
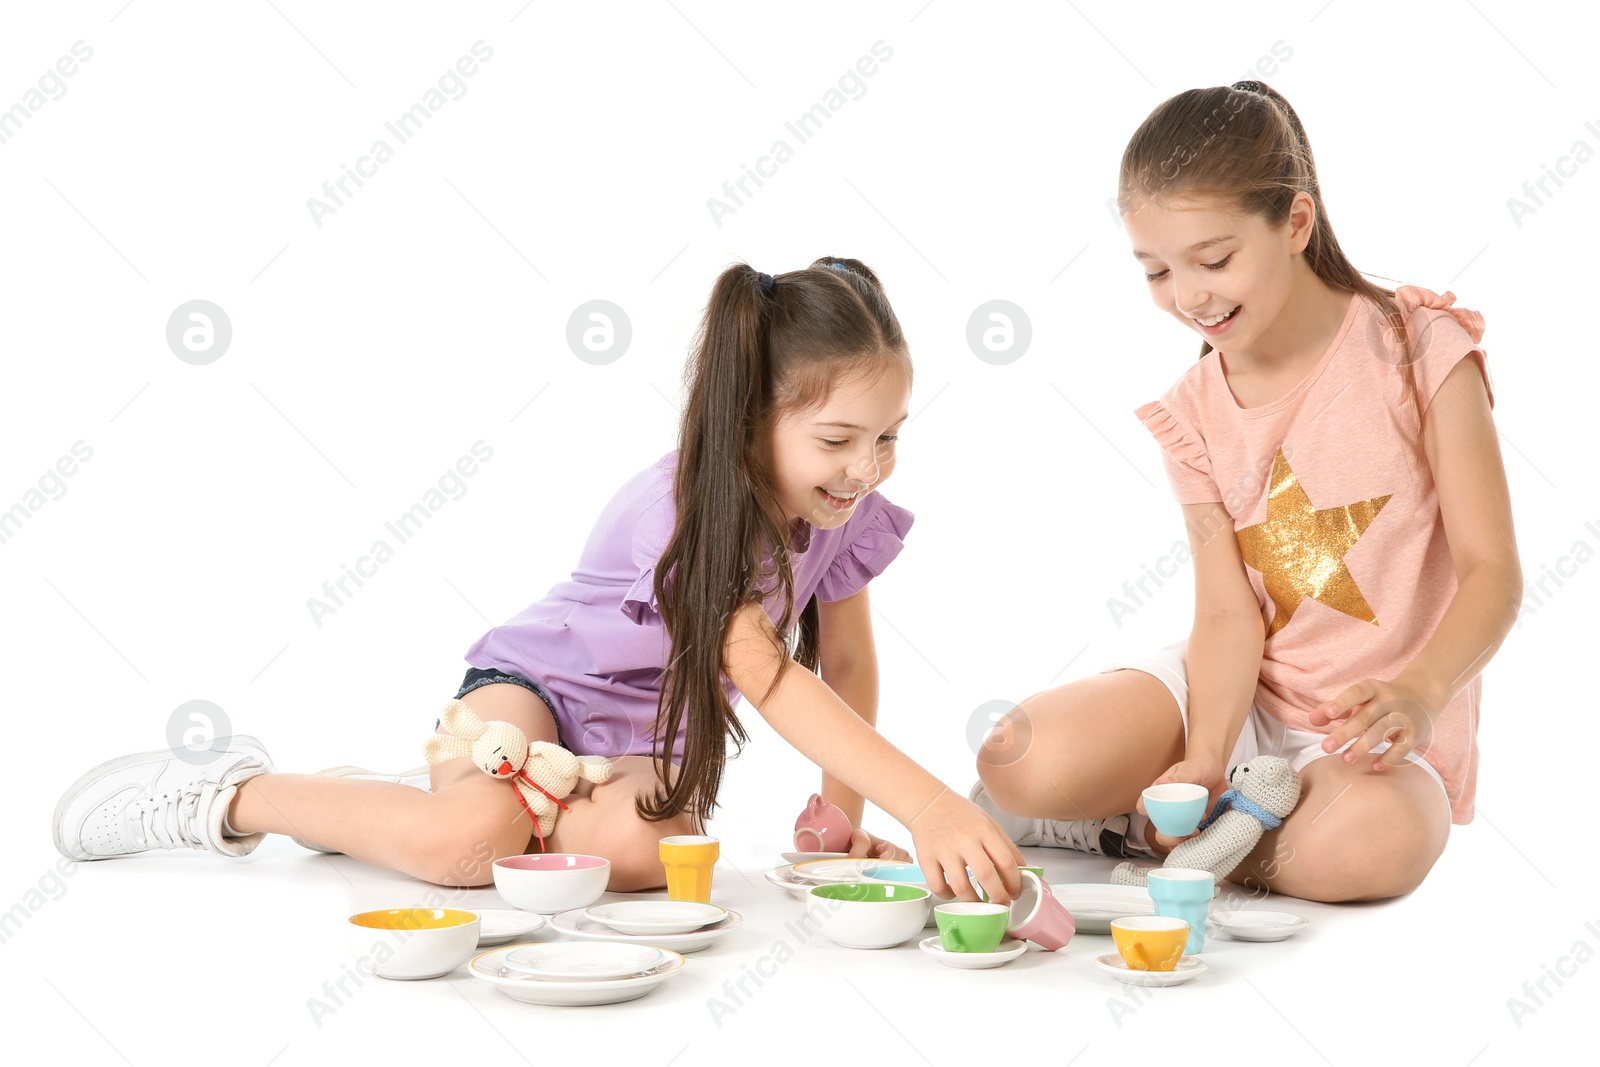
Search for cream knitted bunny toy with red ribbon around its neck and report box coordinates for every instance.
[422,701,611,853]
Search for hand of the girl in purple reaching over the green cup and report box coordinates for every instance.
[910,789,1022,904]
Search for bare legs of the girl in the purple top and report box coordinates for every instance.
[229,683,693,893]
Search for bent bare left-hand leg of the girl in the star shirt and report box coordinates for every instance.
[978,670,1184,819]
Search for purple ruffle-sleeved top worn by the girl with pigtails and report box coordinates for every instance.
[466,451,912,758]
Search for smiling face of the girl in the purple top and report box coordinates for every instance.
[768,366,910,530]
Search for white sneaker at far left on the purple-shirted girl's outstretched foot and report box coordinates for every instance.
[54,734,272,859]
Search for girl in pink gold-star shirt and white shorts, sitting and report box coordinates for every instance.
[973,82,1522,901]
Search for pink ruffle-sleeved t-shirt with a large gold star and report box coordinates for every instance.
[1136,286,1493,824]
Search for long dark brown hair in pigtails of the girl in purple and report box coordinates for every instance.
[637,256,910,822]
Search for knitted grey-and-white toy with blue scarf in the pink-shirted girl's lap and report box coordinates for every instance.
[1110,755,1299,886]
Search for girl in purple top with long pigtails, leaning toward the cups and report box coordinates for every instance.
[54,258,1021,902]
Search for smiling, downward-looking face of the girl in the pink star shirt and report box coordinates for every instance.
[1123,194,1314,355]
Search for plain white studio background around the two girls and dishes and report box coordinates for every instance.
[0,0,1600,1067]
